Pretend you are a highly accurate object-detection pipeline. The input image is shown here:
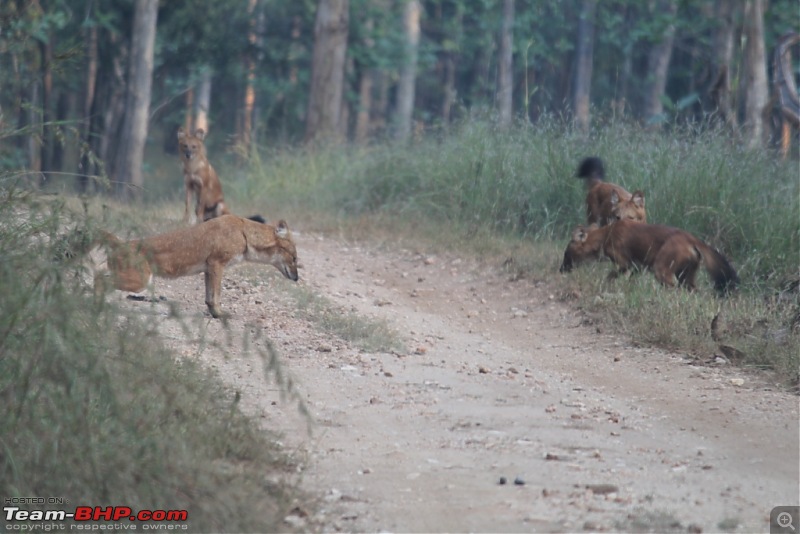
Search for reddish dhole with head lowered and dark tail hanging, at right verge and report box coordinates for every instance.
[560,220,739,293]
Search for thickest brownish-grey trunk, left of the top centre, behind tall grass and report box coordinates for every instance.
[305,0,349,142]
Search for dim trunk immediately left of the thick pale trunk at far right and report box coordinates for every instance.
[708,0,737,128]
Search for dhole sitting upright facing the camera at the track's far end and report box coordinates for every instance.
[178,127,228,224]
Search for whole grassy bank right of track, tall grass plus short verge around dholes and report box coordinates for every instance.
[237,119,800,381]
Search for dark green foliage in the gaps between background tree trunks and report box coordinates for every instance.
[6,0,798,159]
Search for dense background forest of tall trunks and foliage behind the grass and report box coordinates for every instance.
[0,0,800,195]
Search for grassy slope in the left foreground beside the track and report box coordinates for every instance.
[0,189,306,532]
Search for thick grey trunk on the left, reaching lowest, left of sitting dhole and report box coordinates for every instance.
[114,0,158,200]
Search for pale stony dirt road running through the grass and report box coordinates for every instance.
[120,228,800,532]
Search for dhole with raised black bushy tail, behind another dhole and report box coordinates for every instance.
[576,157,647,226]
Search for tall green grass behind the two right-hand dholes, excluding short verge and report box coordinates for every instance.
[239,120,800,285]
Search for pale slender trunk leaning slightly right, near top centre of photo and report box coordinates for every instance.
[395,0,422,141]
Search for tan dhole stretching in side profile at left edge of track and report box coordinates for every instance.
[94,215,298,318]
